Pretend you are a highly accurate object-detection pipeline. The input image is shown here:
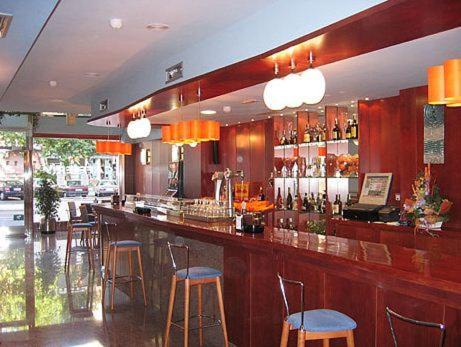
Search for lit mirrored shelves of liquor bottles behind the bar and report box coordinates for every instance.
[272,106,359,231]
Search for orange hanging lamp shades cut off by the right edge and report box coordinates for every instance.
[427,59,461,107]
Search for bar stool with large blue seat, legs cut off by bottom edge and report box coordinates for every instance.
[277,274,357,347]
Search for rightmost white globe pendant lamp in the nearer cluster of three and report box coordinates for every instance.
[301,51,325,105]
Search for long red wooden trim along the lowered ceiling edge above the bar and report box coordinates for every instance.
[88,0,461,126]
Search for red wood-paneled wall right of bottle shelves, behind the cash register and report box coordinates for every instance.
[359,86,461,227]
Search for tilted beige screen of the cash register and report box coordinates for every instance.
[359,172,392,205]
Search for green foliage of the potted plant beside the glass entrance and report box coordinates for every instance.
[35,171,61,220]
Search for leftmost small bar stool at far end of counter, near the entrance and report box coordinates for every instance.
[64,216,94,269]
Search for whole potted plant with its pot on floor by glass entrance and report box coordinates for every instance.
[35,171,61,234]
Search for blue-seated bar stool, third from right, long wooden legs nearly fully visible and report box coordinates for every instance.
[164,242,229,347]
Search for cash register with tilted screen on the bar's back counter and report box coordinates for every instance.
[343,173,392,222]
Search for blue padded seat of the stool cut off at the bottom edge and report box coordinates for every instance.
[286,309,357,332]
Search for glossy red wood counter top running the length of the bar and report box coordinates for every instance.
[94,205,461,306]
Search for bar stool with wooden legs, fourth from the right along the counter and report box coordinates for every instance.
[102,222,147,310]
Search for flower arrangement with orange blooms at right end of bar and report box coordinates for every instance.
[404,164,453,230]
